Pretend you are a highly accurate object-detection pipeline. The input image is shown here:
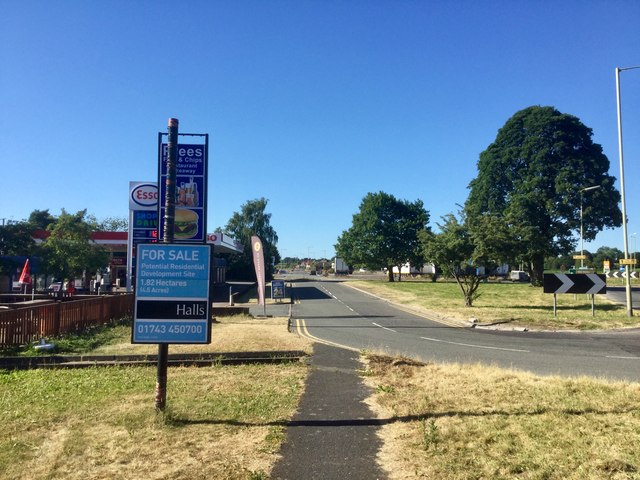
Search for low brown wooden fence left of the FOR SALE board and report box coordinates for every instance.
[0,294,133,348]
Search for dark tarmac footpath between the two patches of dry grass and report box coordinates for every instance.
[270,343,387,480]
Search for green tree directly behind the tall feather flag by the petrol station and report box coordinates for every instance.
[224,198,280,280]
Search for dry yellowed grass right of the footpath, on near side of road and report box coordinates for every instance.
[364,355,640,480]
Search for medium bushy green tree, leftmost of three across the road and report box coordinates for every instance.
[335,192,429,282]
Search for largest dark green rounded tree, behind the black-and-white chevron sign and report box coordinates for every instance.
[465,106,622,284]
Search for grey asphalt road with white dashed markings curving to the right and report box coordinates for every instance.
[292,279,640,381]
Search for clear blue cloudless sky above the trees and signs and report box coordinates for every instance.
[0,0,640,257]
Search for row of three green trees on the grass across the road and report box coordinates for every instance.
[335,106,622,305]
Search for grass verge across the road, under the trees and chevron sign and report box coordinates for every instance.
[349,280,639,330]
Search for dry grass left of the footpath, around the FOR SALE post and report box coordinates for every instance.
[0,317,310,480]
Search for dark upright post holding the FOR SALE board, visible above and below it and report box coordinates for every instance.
[155,118,179,411]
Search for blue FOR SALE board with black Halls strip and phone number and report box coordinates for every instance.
[131,243,211,343]
